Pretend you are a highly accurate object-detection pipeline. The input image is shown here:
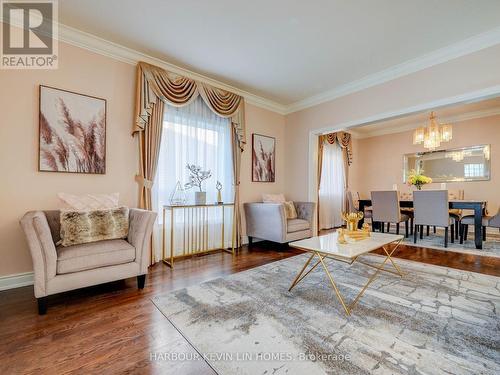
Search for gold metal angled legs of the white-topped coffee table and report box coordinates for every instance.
[288,239,403,316]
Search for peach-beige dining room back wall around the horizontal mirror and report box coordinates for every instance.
[352,115,500,212]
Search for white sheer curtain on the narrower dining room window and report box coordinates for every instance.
[319,142,345,229]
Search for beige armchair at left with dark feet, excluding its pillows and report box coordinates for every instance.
[21,208,156,314]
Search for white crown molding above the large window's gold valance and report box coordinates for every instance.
[54,23,286,115]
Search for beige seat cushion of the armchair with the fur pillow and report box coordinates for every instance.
[57,240,135,274]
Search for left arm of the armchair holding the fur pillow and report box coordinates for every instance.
[20,211,57,298]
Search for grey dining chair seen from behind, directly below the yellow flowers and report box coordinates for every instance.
[413,190,455,247]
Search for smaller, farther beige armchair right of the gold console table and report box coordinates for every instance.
[243,202,315,244]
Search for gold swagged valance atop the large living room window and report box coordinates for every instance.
[133,62,246,150]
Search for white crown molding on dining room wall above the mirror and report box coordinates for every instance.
[349,108,500,139]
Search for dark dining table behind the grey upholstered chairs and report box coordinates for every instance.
[359,199,486,249]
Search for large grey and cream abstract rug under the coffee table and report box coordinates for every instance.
[153,255,500,375]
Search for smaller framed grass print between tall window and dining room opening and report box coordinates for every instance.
[252,133,276,182]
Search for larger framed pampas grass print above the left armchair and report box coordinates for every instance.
[38,85,106,174]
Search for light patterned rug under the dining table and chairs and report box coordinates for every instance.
[400,228,500,258]
